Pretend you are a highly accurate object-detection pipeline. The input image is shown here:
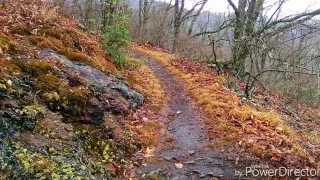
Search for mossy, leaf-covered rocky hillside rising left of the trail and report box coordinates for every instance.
[0,0,144,179]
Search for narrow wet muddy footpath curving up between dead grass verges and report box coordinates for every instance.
[133,55,252,180]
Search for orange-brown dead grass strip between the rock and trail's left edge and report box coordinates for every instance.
[124,58,165,149]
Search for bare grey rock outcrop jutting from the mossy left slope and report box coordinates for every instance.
[38,49,144,114]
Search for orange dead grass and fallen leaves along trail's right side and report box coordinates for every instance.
[130,45,320,166]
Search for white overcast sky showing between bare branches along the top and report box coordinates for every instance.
[165,0,320,15]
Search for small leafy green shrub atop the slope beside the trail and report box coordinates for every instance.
[101,15,130,69]
